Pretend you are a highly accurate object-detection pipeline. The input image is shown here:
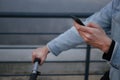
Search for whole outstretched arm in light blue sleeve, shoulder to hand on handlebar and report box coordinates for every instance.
[32,2,112,63]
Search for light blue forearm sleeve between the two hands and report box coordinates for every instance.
[47,27,83,56]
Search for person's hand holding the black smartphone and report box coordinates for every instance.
[74,22,112,53]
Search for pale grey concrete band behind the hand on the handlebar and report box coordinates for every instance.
[0,45,102,61]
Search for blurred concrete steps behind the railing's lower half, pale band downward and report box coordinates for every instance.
[0,45,109,80]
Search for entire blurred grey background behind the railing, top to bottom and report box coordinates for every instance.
[0,0,111,80]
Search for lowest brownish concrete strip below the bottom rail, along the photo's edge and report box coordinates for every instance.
[0,75,102,80]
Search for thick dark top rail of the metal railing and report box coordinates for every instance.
[0,12,93,18]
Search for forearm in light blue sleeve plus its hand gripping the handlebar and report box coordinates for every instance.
[32,27,83,64]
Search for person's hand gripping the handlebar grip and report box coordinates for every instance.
[32,46,49,64]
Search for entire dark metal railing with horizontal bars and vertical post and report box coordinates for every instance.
[0,12,105,80]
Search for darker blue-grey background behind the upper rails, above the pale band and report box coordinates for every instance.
[0,0,110,45]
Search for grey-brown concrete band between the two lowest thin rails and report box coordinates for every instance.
[0,62,109,75]
